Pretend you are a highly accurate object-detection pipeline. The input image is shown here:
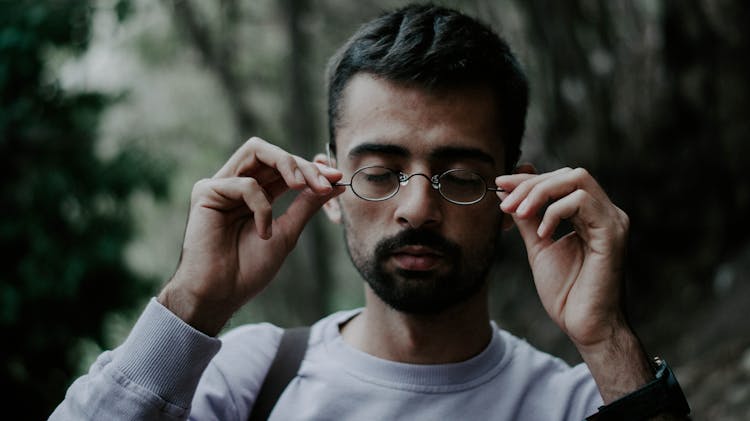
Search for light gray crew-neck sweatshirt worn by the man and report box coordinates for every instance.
[50,299,602,421]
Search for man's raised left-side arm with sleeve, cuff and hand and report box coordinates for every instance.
[50,138,343,420]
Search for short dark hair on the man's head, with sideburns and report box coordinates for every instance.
[328,5,529,171]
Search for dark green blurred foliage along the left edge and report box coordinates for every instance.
[0,1,166,419]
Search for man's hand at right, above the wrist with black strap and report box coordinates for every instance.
[496,168,629,349]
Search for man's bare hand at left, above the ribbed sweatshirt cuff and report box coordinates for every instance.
[158,138,344,335]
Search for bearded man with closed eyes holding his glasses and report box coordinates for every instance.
[52,6,687,420]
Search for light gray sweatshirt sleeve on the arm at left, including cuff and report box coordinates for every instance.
[49,299,221,421]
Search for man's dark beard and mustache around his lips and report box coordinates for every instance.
[344,225,499,315]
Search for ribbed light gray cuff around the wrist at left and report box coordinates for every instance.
[113,298,221,408]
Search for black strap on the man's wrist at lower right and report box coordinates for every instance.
[586,359,690,421]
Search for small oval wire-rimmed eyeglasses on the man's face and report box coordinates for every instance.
[335,166,504,205]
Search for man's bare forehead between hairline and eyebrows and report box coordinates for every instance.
[336,73,503,168]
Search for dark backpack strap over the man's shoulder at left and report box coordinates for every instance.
[249,326,310,421]
